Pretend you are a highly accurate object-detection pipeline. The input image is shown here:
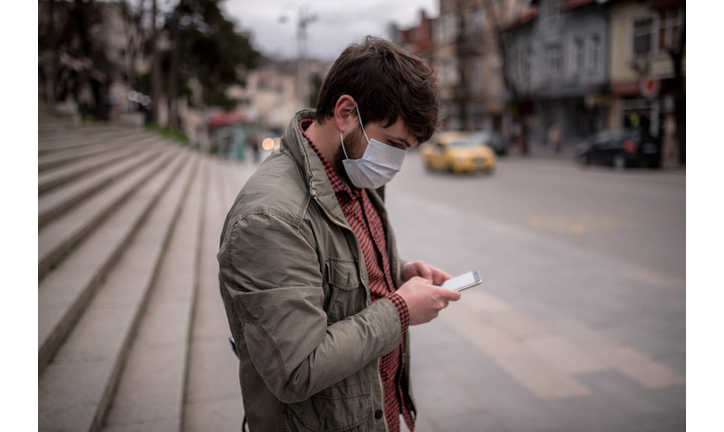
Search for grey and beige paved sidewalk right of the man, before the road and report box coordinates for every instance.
[387,191,686,432]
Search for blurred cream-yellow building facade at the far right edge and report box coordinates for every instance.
[605,0,686,160]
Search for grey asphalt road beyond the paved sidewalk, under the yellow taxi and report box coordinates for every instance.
[388,151,686,278]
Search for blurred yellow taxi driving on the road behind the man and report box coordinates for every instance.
[420,132,497,173]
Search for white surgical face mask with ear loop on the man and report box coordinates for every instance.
[339,104,407,189]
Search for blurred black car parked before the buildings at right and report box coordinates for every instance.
[576,130,661,170]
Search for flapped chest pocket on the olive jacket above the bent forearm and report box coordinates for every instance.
[326,258,365,323]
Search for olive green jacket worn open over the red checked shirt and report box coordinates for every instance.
[217,110,414,431]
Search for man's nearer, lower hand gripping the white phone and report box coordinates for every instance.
[397,276,460,325]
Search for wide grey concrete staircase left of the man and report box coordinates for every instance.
[38,110,253,431]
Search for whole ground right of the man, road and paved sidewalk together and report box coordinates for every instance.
[387,151,686,432]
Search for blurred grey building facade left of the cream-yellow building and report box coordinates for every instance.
[506,0,611,147]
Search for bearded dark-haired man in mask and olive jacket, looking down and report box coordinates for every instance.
[217,37,460,432]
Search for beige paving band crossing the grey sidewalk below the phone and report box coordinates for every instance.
[440,292,686,400]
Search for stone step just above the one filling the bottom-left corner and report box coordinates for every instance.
[38,152,186,372]
